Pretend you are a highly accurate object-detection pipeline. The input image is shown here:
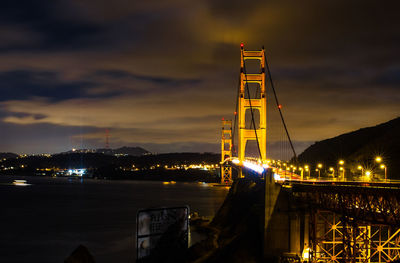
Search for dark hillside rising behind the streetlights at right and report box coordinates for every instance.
[298,117,400,179]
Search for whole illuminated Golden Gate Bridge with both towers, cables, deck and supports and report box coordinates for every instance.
[221,44,400,262]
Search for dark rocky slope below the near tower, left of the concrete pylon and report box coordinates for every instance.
[187,179,265,263]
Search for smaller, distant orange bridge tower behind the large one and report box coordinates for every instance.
[221,119,232,184]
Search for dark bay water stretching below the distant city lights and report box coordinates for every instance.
[0,176,228,263]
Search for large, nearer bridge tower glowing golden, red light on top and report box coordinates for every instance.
[238,44,267,168]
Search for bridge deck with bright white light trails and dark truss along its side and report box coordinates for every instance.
[232,161,400,227]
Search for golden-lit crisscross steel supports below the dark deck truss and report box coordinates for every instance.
[309,210,400,263]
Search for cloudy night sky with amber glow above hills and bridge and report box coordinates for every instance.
[0,0,400,156]
